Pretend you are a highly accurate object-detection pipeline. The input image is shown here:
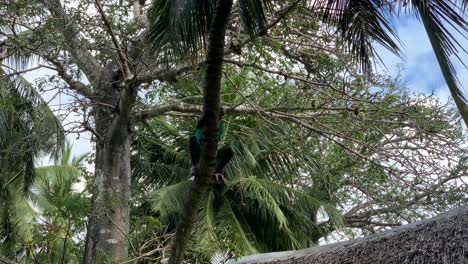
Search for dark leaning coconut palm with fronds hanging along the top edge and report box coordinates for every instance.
[149,0,468,263]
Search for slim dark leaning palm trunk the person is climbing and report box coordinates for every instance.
[169,0,232,264]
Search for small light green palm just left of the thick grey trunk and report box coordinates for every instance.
[26,144,90,263]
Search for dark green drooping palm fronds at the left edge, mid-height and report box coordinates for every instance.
[0,73,65,191]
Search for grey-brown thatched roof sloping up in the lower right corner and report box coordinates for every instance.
[227,205,468,264]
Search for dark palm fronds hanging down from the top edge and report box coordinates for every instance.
[149,0,468,122]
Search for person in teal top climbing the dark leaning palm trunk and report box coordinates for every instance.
[189,108,234,211]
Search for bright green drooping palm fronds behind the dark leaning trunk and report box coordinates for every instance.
[132,119,341,259]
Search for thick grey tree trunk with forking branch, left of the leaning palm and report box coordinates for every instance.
[40,0,142,264]
